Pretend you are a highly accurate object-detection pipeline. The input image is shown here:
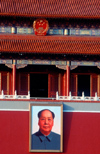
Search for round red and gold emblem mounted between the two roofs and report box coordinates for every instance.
[33,19,49,35]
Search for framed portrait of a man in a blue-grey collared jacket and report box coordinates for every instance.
[30,104,62,152]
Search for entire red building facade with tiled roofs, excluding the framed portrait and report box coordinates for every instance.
[0,0,100,154]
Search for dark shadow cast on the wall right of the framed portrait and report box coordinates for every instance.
[63,104,74,153]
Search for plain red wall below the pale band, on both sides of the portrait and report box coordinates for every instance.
[0,111,100,154]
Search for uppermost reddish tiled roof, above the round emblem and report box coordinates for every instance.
[0,0,100,18]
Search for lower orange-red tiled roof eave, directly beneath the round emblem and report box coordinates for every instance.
[0,34,100,55]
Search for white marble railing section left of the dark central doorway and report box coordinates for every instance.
[0,90,30,99]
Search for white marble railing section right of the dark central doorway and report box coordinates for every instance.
[56,92,100,101]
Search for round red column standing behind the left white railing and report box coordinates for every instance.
[12,60,16,95]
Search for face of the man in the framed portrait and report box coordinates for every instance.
[38,110,53,136]
